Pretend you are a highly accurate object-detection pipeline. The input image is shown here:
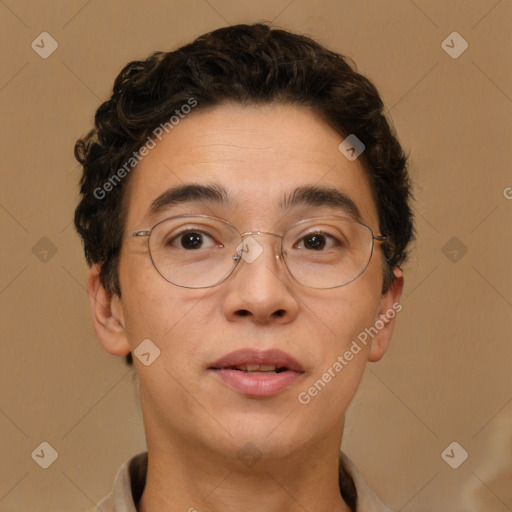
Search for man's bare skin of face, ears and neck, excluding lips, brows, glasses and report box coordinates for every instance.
[88,104,403,512]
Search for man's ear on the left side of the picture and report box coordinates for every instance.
[87,264,130,356]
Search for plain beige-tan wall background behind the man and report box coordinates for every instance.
[0,0,512,512]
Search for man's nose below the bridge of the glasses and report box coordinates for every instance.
[224,233,299,324]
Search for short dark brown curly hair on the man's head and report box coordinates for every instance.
[74,23,413,304]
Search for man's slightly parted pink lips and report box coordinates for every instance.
[208,349,304,398]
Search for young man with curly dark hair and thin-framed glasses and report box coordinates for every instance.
[75,24,413,512]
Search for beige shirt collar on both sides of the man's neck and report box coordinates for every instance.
[95,452,392,512]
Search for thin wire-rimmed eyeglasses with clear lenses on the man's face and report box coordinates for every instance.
[131,214,386,289]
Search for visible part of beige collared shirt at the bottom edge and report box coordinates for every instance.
[95,452,392,512]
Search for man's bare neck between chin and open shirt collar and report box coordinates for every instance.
[138,436,350,512]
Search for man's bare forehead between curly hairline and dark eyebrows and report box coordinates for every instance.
[125,104,378,229]
